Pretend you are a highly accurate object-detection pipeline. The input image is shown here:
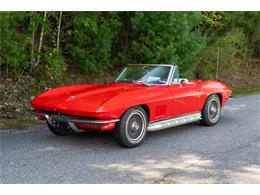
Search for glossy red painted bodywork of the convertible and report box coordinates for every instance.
[31,80,232,130]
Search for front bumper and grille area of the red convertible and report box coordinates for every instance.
[36,112,120,131]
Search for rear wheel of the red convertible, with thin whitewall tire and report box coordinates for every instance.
[201,94,221,126]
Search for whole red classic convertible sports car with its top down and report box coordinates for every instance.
[31,64,232,147]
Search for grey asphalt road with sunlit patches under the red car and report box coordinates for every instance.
[0,94,260,183]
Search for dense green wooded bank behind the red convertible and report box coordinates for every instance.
[0,11,260,123]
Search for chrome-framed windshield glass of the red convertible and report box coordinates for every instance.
[115,65,171,84]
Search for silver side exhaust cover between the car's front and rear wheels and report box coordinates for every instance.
[147,112,201,131]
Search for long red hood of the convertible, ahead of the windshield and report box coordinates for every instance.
[32,83,146,114]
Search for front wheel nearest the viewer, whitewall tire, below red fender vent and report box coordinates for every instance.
[114,106,148,148]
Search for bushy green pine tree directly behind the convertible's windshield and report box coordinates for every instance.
[115,12,205,76]
